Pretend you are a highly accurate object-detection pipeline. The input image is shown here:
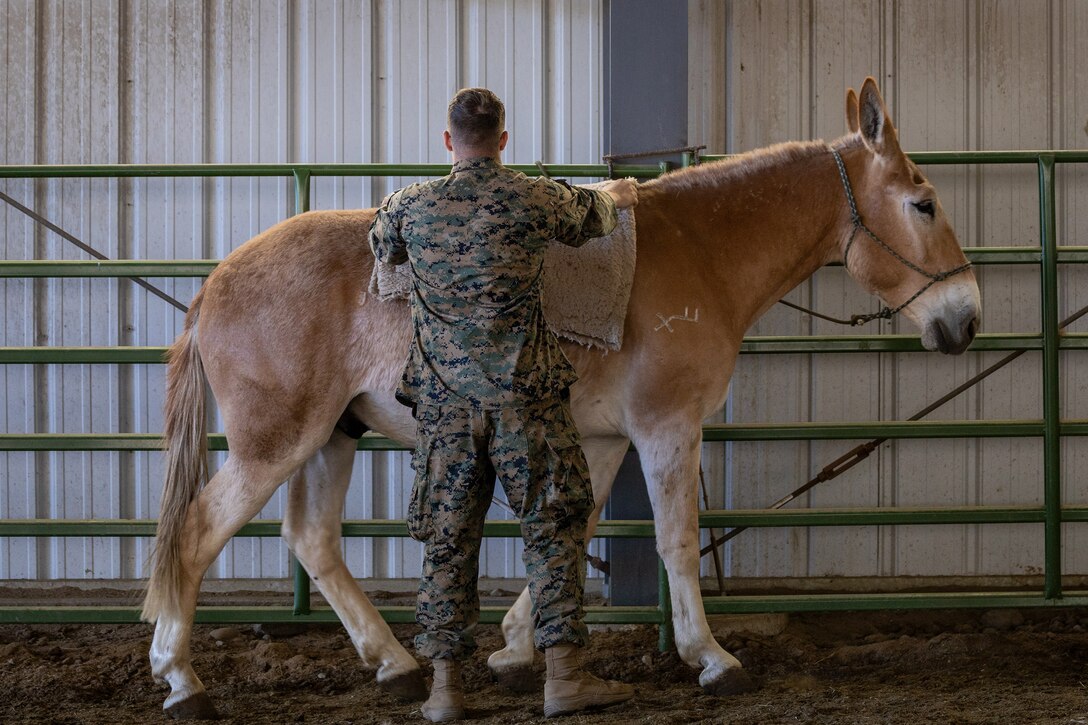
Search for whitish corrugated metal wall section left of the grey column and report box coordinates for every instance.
[0,0,603,579]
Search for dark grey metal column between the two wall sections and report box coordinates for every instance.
[604,0,688,605]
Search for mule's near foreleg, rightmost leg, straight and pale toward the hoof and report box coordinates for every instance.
[639,426,753,695]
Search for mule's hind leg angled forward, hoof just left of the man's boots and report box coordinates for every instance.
[283,431,426,700]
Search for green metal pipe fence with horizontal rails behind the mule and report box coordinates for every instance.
[0,150,1088,644]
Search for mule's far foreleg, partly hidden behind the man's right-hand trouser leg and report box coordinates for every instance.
[487,438,630,692]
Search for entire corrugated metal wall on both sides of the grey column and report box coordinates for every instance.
[0,0,1088,578]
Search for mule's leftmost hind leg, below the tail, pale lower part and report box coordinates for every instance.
[150,455,297,718]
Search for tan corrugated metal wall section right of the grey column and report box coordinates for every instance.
[690,0,1088,577]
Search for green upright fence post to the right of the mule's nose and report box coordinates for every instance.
[1039,153,1062,599]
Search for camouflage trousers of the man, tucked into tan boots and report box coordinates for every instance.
[408,397,593,660]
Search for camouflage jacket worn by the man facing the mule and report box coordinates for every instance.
[370,157,616,408]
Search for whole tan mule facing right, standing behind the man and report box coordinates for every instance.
[144,78,979,716]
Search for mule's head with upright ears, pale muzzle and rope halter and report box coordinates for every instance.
[841,78,980,355]
